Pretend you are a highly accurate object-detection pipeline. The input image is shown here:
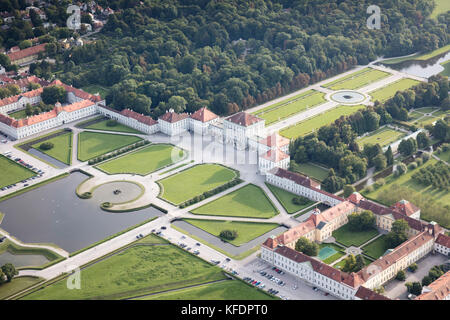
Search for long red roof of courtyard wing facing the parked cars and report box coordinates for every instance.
[275,246,363,288]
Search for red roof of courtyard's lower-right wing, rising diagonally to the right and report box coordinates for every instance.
[358,231,434,281]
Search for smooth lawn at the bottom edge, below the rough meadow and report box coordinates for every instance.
[138,280,276,300]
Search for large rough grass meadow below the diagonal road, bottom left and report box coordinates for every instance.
[24,235,225,300]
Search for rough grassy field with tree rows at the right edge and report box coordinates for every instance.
[363,158,450,228]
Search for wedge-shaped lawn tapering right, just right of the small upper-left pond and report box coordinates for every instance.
[78,131,142,161]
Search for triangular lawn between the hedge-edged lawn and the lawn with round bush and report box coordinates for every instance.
[191,184,278,219]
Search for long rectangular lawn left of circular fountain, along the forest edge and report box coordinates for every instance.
[254,90,325,125]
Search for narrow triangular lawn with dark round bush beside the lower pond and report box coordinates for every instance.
[183,219,279,246]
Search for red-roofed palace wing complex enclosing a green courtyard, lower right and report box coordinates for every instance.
[261,168,450,300]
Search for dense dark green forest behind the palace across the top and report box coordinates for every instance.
[19,0,450,117]
